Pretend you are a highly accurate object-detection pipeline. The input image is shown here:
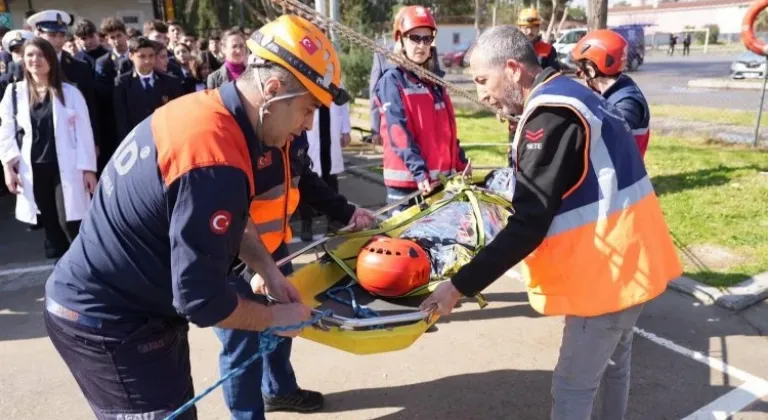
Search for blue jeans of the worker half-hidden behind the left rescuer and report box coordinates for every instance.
[213,244,298,420]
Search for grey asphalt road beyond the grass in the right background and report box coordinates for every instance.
[440,52,768,110]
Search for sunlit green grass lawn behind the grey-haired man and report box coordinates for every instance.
[352,107,768,286]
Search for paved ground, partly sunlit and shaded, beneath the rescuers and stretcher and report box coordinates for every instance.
[0,169,768,420]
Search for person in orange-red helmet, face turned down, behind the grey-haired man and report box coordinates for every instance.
[571,29,651,157]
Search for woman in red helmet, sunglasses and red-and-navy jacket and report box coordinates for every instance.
[372,6,467,212]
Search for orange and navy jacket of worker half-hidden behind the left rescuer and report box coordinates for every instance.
[250,132,355,253]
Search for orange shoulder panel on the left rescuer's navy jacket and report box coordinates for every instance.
[152,90,255,196]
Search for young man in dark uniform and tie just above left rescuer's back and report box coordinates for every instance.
[114,37,184,139]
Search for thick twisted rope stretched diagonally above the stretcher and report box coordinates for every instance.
[272,0,517,120]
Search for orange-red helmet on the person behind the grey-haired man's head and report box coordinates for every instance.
[571,29,628,76]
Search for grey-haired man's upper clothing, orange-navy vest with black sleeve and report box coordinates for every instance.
[451,69,682,317]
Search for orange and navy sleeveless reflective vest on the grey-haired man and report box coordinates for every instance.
[515,75,682,316]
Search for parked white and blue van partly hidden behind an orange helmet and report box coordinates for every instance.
[552,25,645,71]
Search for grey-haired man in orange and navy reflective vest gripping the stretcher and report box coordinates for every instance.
[422,25,682,420]
